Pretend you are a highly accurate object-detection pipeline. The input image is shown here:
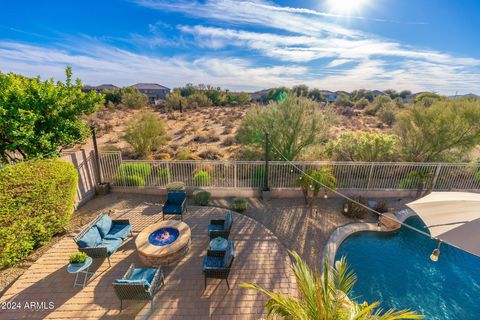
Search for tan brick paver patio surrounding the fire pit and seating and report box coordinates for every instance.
[0,199,296,319]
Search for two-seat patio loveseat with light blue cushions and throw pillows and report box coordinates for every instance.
[73,214,132,266]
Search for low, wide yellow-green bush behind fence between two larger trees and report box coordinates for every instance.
[326,132,398,162]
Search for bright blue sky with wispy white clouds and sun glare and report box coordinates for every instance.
[0,0,480,95]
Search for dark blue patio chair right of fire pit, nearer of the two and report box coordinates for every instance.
[202,241,235,289]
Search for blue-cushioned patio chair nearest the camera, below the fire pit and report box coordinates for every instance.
[112,264,165,311]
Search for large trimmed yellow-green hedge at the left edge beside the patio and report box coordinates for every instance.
[0,160,78,268]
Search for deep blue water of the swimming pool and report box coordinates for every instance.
[336,217,480,320]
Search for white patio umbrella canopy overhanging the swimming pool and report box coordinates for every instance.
[407,192,480,260]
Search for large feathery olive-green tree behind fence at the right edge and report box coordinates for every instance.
[394,99,480,162]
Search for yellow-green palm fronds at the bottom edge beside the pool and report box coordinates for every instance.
[240,251,423,320]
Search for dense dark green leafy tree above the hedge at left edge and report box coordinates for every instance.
[0,67,103,162]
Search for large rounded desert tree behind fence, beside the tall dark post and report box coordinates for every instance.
[237,96,335,160]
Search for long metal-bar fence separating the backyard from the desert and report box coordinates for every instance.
[100,152,480,190]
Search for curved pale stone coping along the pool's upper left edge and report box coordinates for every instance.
[320,209,417,269]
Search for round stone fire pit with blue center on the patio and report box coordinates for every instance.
[135,220,191,266]
